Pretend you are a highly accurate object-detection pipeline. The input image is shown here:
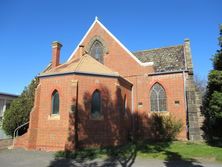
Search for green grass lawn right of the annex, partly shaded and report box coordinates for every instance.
[138,141,222,162]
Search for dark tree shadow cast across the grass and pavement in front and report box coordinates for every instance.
[49,141,206,167]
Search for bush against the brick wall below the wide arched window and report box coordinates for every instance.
[150,114,183,140]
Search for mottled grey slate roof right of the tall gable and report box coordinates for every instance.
[133,45,185,72]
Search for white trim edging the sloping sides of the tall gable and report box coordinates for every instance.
[67,17,153,66]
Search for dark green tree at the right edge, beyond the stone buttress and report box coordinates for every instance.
[203,25,222,141]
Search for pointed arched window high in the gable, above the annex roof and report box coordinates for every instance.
[89,40,103,63]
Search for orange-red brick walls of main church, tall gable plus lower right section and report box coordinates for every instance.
[70,23,186,139]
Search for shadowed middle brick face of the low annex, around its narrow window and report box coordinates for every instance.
[72,76,131,146]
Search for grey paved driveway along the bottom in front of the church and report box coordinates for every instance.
[0,149,222,167]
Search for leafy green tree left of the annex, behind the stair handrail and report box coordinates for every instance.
[2,78,39,136]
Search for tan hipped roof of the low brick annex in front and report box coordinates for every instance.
[40,54,119,76]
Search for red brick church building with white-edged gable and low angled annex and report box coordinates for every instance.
[15,18,201,151]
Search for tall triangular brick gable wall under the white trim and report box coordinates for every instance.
[70,23,153,126]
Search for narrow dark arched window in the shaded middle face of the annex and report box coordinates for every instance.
[91,90,101,118]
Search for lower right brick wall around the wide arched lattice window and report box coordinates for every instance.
[135,73,187,139]
